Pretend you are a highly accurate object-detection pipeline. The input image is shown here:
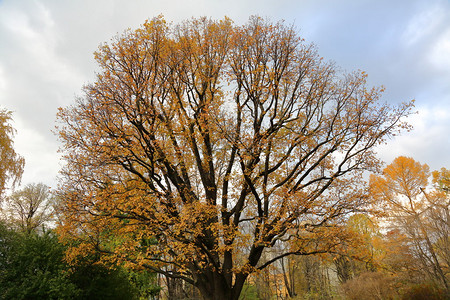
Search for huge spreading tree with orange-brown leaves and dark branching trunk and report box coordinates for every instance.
[59,17,411,299]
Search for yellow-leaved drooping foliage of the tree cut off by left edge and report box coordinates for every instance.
[0,109,25,197]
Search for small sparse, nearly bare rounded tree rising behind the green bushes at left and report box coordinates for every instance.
[5,183,54,233]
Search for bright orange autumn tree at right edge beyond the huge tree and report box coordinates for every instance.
[370,156,450,293]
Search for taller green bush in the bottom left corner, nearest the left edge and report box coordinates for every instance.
[0,224,79,299]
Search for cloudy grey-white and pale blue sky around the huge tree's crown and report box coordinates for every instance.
[0,0,450,187]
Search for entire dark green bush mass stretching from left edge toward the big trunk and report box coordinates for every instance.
[0,222,159,300]
